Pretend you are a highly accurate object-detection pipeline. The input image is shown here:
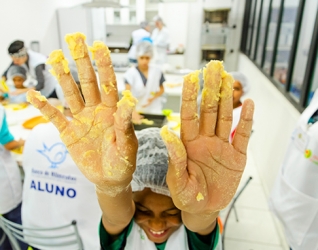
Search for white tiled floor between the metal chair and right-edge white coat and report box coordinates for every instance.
[220,146,289,250]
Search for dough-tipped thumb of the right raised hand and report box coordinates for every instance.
[160,126,189,194]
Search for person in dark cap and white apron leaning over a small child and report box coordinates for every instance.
[2,40,58,98]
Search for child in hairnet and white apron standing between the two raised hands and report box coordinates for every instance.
[124,41,165,123]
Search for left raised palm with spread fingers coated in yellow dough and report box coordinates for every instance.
[28,33,138,195]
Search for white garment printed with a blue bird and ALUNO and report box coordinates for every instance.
[22,123,102,250]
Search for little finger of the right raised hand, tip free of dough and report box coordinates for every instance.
[232,99,254,155]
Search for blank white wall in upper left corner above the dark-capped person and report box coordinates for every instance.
[0,0,88,74]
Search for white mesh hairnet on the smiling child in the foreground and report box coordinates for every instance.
[131,128,170,196]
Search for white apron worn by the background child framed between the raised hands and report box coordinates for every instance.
[124,66,163,114]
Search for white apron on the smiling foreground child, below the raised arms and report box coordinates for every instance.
[125,222,189,250]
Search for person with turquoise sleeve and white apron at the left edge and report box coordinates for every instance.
[0,105,27,250]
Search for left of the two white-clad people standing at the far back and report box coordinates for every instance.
[128,21,150,63]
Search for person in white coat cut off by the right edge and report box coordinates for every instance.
[269,90,318,250]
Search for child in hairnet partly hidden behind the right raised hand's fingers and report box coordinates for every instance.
[229,72,250,142]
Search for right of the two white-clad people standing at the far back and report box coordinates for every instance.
[151,16,170,65]
